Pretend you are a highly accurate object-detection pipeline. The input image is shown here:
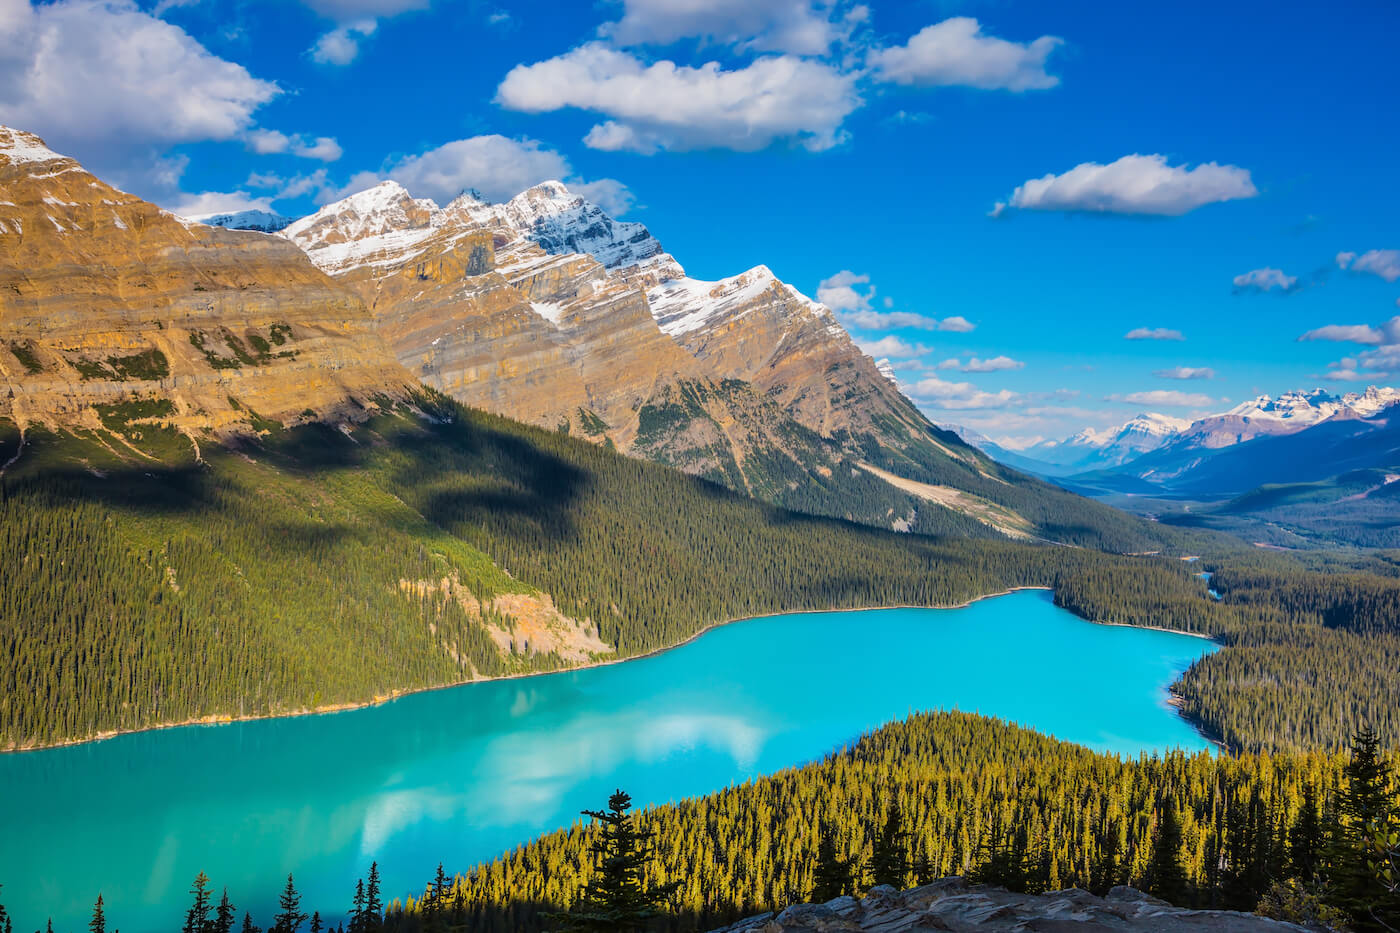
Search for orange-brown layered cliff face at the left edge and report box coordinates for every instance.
[0,127,412,434]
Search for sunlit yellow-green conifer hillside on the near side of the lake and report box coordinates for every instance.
[431,713,1400,932]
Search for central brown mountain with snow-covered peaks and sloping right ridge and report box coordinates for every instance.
[281,182,1159,537]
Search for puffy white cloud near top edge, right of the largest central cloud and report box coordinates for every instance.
[867,17,1064,91]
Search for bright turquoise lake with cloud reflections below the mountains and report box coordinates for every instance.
[0,591,1215,933]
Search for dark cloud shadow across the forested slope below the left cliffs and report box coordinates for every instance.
[7,412,592,549]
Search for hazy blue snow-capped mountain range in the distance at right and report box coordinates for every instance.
[960,385,1400,548]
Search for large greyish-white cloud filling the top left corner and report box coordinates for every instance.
[0,0,280,161]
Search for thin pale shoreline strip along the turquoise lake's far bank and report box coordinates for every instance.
[0,586,1225,755]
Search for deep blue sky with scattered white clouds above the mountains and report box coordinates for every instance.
[0,0,1400,443]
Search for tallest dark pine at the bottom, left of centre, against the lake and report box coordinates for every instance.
[547,790,680,933]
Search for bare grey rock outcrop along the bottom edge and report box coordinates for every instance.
[717,878,1303,933]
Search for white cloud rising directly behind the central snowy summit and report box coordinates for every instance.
[330,134,631,213]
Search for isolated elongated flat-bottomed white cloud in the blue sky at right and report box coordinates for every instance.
[993,154,1259,217]
